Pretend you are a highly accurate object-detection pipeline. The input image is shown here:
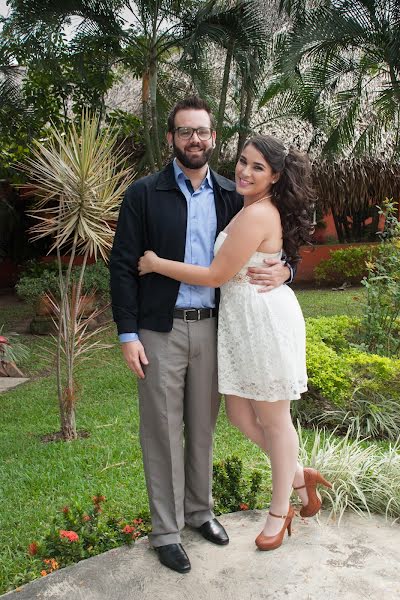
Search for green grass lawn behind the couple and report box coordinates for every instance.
[0,289,363,593]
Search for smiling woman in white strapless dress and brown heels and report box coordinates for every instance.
[139,136,330,550]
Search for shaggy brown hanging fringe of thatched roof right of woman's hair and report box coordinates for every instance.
[313,157,400,213]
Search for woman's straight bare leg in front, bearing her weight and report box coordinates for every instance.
[251,400,299,536]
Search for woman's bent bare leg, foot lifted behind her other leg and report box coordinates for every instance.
[225,396,308,512]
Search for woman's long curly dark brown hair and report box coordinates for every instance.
[244,135,315,264]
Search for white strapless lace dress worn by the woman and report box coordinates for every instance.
[214,231,307,402]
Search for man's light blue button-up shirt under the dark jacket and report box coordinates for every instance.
[119,159,217,342]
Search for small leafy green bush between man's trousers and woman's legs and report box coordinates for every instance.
[213,456,261,515]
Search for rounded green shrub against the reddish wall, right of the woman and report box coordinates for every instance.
[314,245,378,284]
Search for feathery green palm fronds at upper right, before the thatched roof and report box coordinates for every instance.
[261,0,400,155]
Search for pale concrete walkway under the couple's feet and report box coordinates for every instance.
[1,511,400,600]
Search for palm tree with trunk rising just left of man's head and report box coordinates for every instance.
[5,0,201,171]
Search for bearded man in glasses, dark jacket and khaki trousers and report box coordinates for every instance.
[110,97,291,573]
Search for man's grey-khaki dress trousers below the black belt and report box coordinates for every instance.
[138,318,219,547]
